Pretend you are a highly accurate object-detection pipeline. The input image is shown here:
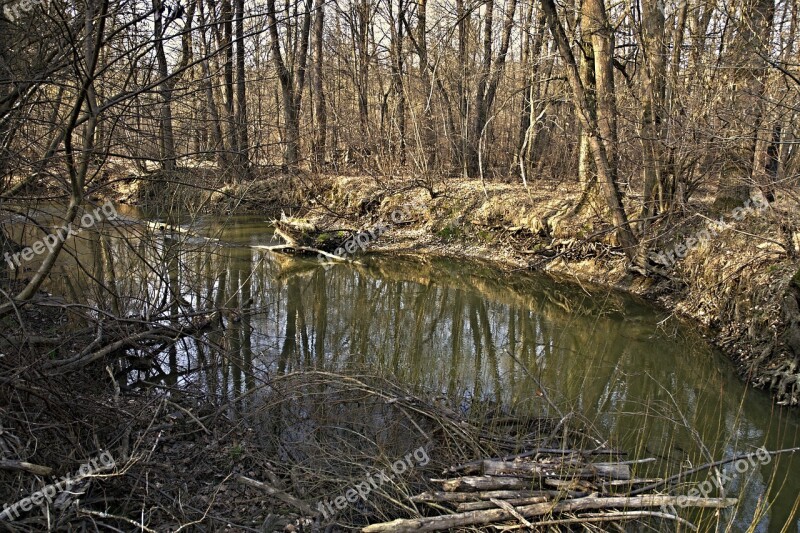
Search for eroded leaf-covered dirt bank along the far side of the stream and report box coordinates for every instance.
[194,172,800,405]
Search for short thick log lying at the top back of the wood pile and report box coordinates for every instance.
[483,460,631,479]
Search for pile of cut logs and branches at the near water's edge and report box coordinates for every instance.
[362,449,736,533]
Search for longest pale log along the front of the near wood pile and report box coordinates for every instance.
[361,494,737,533]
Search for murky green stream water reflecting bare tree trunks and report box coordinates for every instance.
[7,206,800,532]
